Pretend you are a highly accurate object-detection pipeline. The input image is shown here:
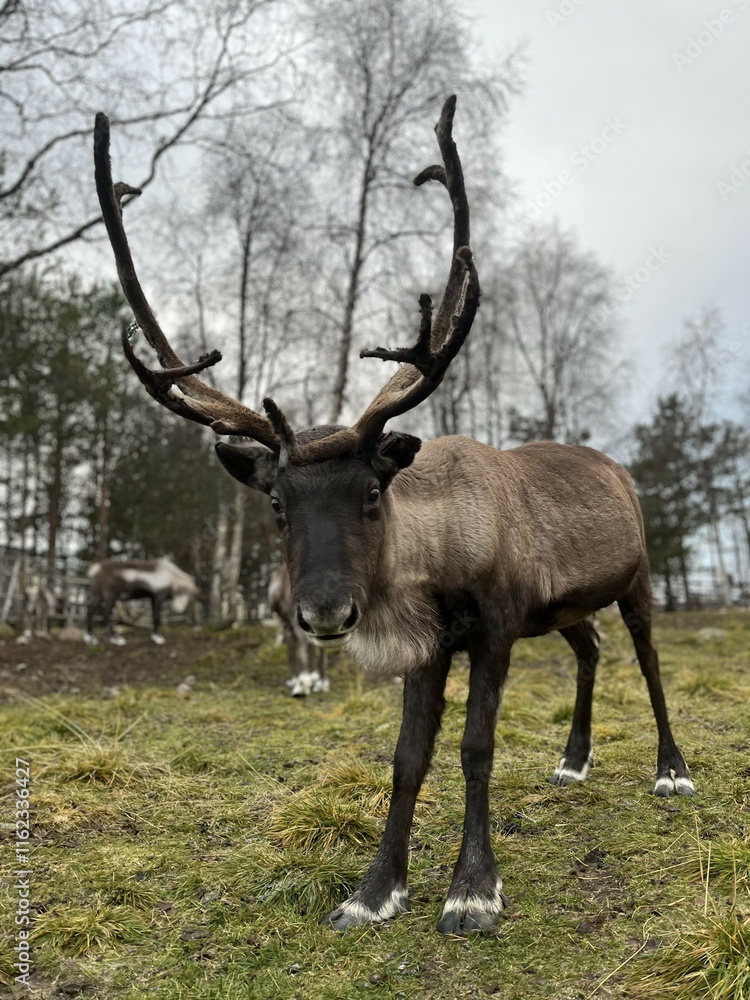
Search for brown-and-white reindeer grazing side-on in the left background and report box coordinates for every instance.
[83,559,198,646]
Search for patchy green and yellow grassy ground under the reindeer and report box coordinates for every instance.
[0,613,750,1000]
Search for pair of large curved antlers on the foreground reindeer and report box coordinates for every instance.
[94,96,479,465]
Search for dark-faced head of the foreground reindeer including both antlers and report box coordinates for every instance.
[94,97,479,646]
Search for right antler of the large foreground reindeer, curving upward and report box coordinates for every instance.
[293,95,479,464]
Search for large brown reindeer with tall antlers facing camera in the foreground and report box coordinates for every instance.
[94,97,694,934]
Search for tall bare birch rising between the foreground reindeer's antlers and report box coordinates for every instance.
[307,0,518,423]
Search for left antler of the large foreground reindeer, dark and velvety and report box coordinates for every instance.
[94,112,281,453]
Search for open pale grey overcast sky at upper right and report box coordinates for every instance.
[473,0,750,419]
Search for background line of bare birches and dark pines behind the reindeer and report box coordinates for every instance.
[0,0,750,619]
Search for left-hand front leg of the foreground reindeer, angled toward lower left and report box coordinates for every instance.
[323,652,451,931]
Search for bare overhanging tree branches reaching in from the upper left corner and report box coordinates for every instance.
[0,0,290,276]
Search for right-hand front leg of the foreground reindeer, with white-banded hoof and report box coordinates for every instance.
[437,636,510,934]
